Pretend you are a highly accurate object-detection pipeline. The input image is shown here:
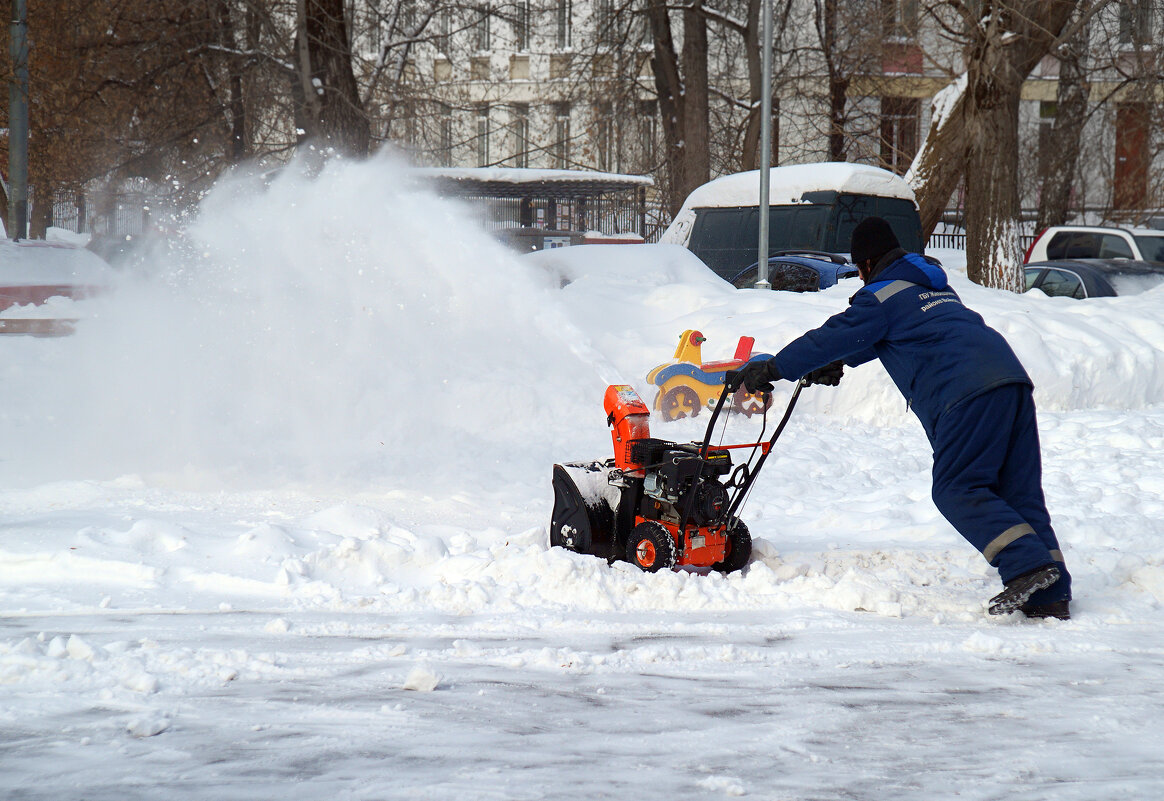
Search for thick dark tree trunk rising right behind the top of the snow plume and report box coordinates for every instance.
[298,0,371,157]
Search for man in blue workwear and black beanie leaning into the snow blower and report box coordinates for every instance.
[730,217,1071,621]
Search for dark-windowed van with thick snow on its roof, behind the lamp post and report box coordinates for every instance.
[659,162,923,279]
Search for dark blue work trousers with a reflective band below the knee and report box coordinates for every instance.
[931,384,1071,604]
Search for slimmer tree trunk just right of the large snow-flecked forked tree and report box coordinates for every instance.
[1037,28,1090,231]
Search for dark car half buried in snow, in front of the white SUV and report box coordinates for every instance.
[1023,258,1164,298]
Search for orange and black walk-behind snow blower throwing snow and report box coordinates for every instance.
[549,381,805,573]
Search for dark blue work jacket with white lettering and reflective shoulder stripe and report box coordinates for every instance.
[773,251,1031,440]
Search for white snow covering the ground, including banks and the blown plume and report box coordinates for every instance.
[0,163,1164,801]
